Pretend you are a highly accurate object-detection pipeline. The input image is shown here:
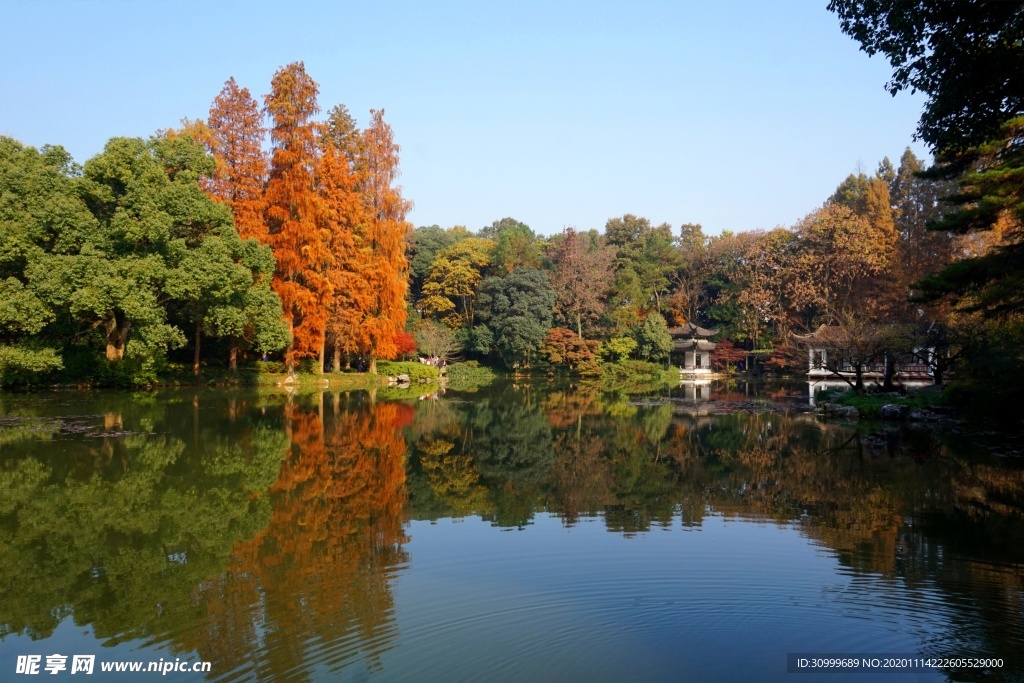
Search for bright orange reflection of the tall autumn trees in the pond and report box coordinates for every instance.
[194,394,415,680]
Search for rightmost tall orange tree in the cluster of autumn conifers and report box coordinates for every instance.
[361,110,412,373]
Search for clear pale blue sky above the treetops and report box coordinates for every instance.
[0,0,926,234]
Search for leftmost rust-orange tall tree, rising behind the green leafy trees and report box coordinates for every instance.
[204,78,267,242]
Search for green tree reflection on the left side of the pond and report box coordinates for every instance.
[0,398,287,644]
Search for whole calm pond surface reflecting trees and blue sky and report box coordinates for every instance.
[0,384,1024,683]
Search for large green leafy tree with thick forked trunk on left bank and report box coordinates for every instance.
[33,138,204,370]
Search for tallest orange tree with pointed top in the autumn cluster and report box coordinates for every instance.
[264,61,333,370]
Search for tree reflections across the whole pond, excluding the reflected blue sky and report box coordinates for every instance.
[0,385,1024,681]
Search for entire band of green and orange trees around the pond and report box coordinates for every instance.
[0,0,1024,423]
